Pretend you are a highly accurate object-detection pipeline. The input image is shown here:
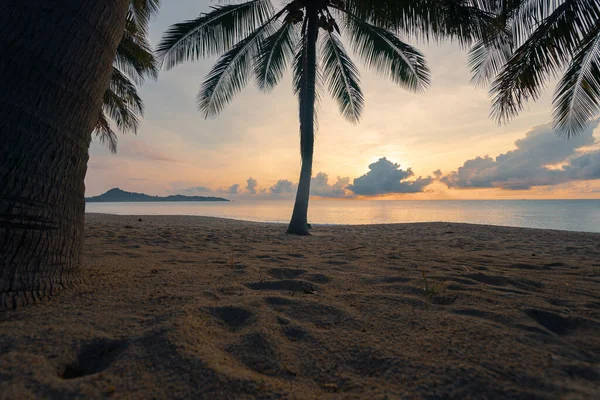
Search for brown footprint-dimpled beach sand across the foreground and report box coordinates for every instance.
[0,214,600,399]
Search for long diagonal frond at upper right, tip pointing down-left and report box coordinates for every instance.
[491,0,593,122]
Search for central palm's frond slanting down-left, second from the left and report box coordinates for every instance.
[197,10,285,117]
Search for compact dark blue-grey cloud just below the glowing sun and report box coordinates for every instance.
[348,157,433,196]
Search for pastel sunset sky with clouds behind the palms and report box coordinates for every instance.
[86,0,600,200]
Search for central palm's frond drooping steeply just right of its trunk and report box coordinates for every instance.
[321,33,364,122]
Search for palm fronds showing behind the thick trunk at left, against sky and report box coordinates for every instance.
[93,0,160,153]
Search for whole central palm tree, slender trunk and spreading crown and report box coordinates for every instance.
[157,0,429,235]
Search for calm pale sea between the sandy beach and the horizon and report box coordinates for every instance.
[86,200,600,232]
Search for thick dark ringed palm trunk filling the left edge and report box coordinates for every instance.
[0,0,130,308]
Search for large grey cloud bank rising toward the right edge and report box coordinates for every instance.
[440,120,600,190]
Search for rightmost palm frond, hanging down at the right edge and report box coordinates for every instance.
[553,21,600,137]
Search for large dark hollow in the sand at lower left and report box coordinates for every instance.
[58,338,128,379]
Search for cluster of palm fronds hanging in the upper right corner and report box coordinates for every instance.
[470,0,600,137]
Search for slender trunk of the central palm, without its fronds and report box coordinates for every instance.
[287,5,319,235]
